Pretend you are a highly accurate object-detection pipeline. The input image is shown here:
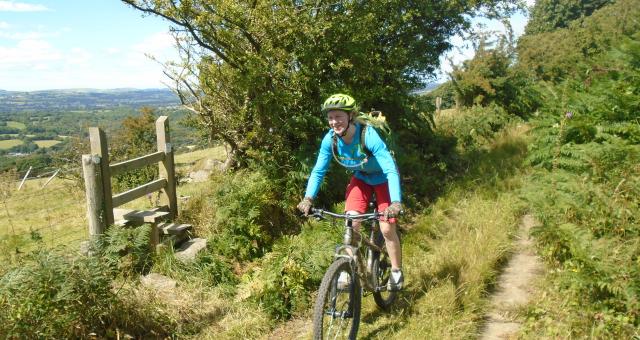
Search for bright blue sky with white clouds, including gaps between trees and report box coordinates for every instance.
[0,0,533,91]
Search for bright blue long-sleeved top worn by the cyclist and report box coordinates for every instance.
[305,123,401,202]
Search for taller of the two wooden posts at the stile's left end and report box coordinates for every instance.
[89,127,113,225]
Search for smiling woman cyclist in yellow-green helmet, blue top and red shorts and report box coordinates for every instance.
[297,93,404,291]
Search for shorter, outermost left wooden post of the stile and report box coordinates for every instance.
[82,155,106,239]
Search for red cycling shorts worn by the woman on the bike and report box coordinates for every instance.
[344,177,396,223]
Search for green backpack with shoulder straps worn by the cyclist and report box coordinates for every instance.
[331,111,395,168]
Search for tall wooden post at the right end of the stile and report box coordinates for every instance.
[156,116,178,219]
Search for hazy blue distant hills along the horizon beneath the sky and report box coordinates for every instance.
[0,89,180,113]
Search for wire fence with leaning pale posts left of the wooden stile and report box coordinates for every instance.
[0,166,89,261]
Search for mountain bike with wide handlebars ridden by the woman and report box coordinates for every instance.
[310,204,397,339]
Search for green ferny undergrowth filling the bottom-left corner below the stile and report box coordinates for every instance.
[0,251,176,339]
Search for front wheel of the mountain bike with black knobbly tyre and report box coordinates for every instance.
[313,258,362,339]
